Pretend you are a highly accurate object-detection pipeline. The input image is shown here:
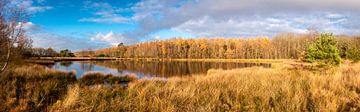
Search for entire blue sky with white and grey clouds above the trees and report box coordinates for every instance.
[17,0,360,51]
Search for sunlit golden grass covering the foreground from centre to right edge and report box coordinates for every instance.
[53,64,360,112]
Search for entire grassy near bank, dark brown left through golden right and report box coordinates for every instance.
[0,64,360,111]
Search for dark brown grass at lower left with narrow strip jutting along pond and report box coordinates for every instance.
[0,65,135,112]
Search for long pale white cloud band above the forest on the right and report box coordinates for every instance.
[172,13,359,37]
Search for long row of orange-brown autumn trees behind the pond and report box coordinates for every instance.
[83,33,360,59]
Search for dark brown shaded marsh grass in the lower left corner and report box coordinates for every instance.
[0,66,76,111]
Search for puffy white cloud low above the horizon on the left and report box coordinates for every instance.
[28,31,137,51]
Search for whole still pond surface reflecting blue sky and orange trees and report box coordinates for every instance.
[47,61,271,78]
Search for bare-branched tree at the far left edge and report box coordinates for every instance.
[0,0,27,73]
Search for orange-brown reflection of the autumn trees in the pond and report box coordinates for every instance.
[96,61,271,77]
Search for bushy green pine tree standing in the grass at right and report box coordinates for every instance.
[305,33,341,65]
